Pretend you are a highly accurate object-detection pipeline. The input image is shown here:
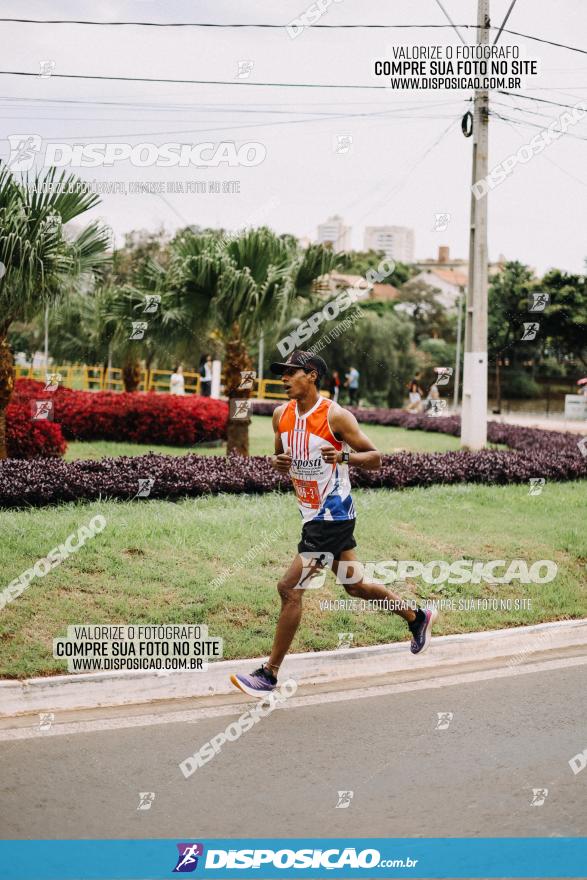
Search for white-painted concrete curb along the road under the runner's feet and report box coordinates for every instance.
[0,619,587,718]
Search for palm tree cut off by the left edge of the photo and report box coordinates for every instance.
[0,164,109,459]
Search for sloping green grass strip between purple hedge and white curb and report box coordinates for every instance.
[0,482,587,677]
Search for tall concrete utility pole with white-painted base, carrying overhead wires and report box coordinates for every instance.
[461,0,490,449]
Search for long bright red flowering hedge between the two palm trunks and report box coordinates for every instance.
[13,379,228,446]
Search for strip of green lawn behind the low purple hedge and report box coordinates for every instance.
[65,416,468,461]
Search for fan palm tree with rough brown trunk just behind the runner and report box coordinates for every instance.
[159,227,342,455]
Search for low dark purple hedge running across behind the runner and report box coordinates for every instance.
[0,401,587,507]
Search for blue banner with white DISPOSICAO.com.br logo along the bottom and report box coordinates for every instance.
[0,837,587,880]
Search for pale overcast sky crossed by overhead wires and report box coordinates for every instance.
[0,0,587,272]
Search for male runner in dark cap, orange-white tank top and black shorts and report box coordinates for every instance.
[231,351,437,698]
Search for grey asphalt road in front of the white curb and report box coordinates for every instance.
[0,665,587,840]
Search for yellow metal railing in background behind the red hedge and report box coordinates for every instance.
[15,364,294,400]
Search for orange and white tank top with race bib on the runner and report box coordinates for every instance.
[278,397,356,522]
